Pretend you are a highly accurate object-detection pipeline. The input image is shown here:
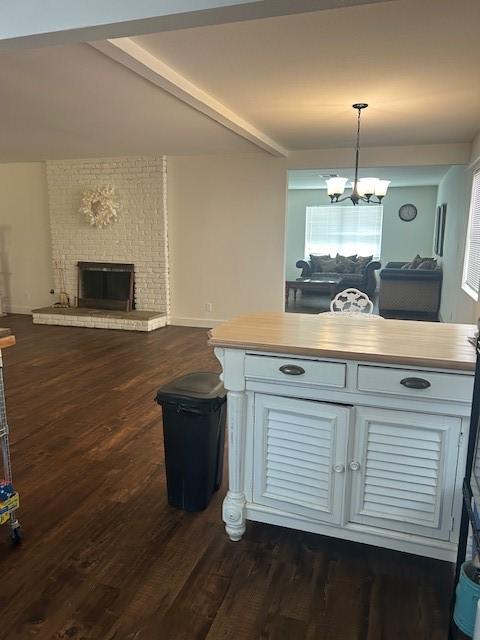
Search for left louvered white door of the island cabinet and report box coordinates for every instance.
[253,394,352,524]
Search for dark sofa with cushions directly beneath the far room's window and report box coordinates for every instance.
[296,253,382,297]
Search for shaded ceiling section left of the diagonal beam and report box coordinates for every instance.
[0,44,255,161]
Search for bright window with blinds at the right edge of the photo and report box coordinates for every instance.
[462,170,480,300]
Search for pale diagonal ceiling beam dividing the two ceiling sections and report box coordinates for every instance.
[90,38,288,157]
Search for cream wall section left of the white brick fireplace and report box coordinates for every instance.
[0,162,53,313]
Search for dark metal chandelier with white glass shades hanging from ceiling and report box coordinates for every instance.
[326,102,390,204]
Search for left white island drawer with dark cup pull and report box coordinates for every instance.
[245,356,346,388]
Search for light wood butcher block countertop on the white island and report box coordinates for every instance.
[209,312,476,371]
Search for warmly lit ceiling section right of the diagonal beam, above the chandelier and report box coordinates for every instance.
[133,0,480,149]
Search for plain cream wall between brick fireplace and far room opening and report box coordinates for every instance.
[168,155,286,326]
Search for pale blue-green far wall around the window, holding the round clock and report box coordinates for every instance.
[285,182,437,279]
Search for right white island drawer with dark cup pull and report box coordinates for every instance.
[358,365,473,402]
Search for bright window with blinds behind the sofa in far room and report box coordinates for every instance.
[305,205,383,258]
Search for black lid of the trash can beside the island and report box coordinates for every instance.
[156,371,226,406]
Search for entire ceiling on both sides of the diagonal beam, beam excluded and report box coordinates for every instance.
[0,0,480,160]
